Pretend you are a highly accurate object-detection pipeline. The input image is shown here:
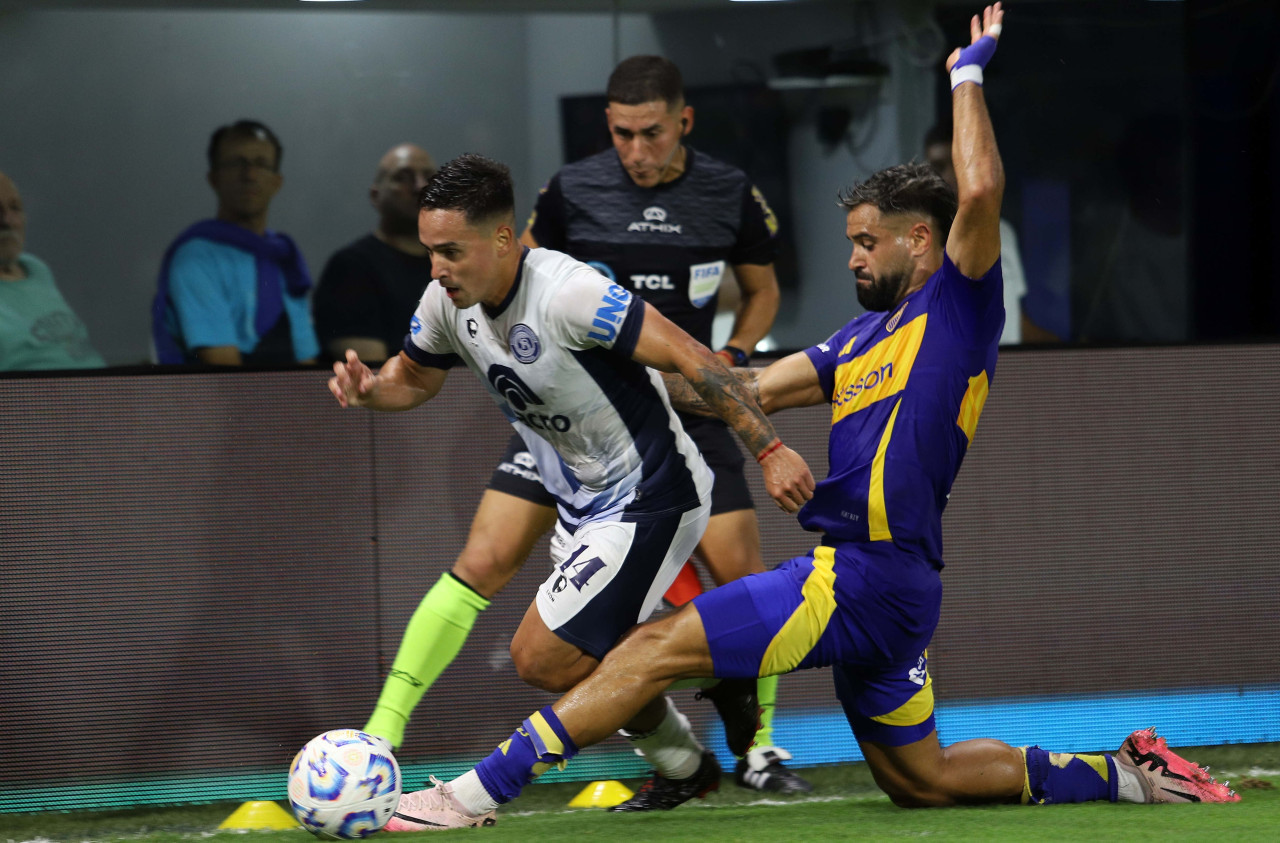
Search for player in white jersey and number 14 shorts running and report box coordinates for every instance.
[329,155,814,830]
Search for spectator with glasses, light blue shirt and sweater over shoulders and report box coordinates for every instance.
[151,120,320,366]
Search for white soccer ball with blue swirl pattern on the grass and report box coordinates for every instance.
[289,729,401,840]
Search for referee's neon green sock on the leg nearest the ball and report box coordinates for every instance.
[365,572,489,748]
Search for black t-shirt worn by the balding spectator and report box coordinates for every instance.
[311,234,431,358]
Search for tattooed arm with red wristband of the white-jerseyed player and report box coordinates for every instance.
[632,302,814,512]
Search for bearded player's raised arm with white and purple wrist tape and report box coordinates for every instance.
[946,3,1005,278]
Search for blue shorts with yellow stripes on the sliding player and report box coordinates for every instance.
[694,541,942,746]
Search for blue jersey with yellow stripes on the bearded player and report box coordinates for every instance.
[800,255,1005,568]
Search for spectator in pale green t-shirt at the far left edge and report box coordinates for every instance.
[0,173,105,372]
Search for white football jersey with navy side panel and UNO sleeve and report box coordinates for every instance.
[404,248,712,530]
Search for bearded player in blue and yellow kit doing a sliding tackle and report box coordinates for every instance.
[389,3,1238,829]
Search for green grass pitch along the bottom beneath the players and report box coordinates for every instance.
[0,743,1280,843]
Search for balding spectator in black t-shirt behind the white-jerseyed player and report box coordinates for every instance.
[312,143,435,362]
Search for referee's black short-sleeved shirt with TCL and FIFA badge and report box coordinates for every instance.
[529,147,778,345]
